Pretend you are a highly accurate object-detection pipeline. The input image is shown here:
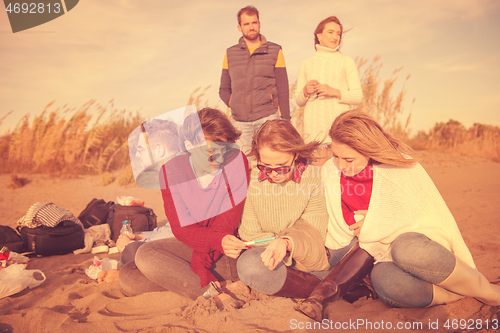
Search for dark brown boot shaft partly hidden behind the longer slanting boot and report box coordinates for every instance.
[272,266,321,298]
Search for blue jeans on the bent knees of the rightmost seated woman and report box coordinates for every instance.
[370,232,455,308]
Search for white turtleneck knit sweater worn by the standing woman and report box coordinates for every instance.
[295,45,363,142]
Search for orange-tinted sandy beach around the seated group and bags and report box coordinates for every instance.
[0,152,500,333]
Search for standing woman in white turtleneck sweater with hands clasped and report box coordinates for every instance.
[295,16,363,143]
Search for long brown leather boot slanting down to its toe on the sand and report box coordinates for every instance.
[297,243,374,321]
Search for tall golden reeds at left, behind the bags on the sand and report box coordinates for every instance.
[0,100,143,174]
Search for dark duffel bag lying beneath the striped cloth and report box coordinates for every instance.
[20,220,85,256]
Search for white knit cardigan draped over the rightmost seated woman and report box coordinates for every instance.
[322,160,475,268]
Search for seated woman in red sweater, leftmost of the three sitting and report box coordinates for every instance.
[120,108,248,306]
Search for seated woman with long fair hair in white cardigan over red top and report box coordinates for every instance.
[305,110,500,313]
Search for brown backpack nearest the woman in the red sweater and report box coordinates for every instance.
[108,204,156,242]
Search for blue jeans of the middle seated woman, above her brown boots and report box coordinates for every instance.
[236,237,358,295]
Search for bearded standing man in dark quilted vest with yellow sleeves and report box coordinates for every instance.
[219,6,290,153]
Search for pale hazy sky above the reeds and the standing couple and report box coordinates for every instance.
[0,0,500,134]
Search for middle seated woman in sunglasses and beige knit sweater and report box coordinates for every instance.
[237,119,329,297]
